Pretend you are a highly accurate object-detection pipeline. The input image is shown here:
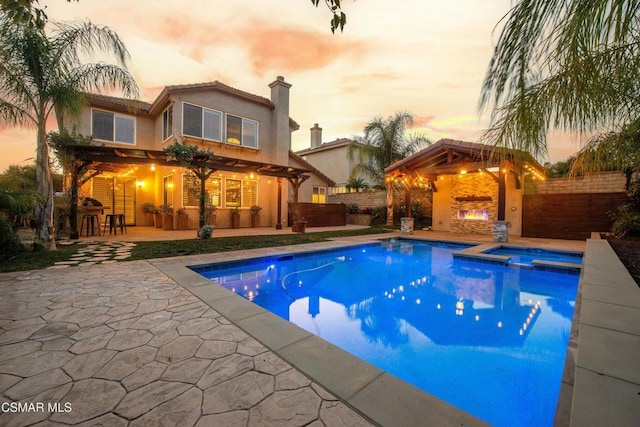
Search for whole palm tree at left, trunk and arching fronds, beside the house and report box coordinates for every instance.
[0,14,137,249]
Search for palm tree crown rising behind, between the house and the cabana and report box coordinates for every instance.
[348,112,431,188]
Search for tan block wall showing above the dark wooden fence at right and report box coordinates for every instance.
[525,171,626,194]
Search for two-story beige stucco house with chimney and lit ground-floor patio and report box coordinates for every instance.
[75,76,333,228]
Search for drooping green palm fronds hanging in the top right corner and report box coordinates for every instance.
[480,0,640,161]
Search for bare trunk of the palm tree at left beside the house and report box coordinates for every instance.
[36,113,56,250]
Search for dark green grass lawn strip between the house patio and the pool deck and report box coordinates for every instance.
[0,227,395,272]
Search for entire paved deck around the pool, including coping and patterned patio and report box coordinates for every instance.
[0,227,640,426]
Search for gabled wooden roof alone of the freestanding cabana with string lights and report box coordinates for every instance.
[385,139,544,176]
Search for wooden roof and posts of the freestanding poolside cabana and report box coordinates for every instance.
[385,139,544,225]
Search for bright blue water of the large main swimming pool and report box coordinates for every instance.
[194,241,579,426]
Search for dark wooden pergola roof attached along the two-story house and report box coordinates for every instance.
[63,145,310,178]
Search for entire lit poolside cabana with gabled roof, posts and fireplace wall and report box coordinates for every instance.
[385,139,544,239]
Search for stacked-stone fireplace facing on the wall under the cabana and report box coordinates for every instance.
[450,173,498,234]
